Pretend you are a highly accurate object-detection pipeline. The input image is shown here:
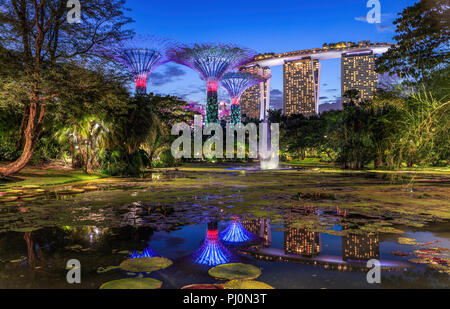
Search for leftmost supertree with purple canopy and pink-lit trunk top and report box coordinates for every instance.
[96,35,173,95]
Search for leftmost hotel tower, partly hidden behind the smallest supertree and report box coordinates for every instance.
[241,65,272,120]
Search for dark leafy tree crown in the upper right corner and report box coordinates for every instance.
[377,0,450,82]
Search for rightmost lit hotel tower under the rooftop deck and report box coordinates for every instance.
[341,51,378,104]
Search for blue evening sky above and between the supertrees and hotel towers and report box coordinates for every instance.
[127,0,417,108]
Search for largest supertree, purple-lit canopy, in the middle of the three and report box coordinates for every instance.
[169,44,256,123]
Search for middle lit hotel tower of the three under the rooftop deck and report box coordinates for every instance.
[283,58,321,116]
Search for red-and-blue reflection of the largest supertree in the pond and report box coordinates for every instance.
[194,222,231,266]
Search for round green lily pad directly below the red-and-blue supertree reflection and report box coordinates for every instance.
[208,263,261,280]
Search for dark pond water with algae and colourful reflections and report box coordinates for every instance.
[0,169,450,289]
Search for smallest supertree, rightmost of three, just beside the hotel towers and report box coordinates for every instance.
[221,72,270,124]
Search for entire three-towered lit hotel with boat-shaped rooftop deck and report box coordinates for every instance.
[241,41,393,120]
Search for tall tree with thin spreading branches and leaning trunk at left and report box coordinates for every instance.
[0,0,132,176]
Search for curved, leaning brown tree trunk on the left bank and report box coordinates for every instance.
[0,99,45,177]
